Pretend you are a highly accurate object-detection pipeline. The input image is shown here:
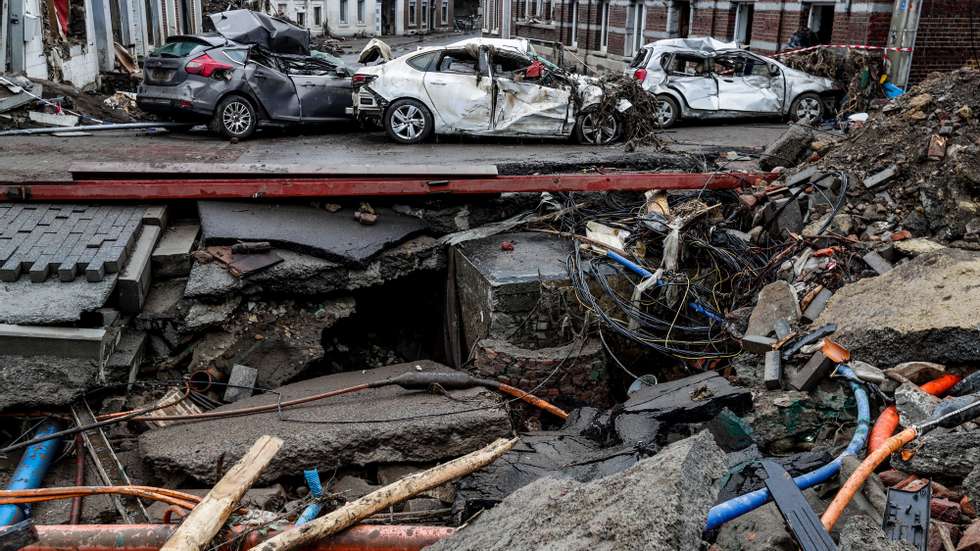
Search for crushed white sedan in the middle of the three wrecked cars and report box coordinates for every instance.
[350,38,630,145]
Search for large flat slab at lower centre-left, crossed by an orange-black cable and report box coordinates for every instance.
[140,361,511,484]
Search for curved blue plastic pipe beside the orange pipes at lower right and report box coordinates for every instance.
[705,365,871,530]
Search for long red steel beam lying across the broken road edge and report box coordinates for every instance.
[0,172,773,202]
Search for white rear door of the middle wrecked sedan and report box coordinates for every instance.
[423,50,493,134]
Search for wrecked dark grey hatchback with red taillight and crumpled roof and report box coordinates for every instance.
[136,10,352,139]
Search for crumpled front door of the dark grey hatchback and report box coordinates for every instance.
[289,58,353,121]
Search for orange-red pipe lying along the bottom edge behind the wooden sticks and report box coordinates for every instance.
[21,524,455,551]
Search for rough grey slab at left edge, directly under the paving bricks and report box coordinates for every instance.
[0,274,117,325]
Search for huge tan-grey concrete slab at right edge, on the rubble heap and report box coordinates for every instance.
[816,248,980,367]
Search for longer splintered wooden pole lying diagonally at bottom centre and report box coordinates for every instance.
[252,438,518,551]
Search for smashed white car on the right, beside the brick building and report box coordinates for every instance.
[626,38,844,128]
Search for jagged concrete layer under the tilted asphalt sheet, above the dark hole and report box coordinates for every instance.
[185,235,446,300]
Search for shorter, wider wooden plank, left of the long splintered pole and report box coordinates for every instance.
[160,435,282,551]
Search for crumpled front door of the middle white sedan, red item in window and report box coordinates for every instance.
[491,52,573,136]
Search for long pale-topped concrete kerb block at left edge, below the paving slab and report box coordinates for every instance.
[0,324,110,365]
